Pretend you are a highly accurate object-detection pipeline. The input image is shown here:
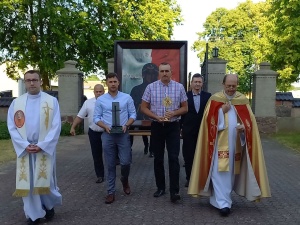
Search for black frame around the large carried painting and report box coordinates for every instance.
[114,40,188,94]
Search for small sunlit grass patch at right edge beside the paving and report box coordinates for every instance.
[271,132,300,152]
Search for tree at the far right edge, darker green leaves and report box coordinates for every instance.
[266,0,300,91]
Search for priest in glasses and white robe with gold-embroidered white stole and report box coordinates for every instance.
[7,70,62,224]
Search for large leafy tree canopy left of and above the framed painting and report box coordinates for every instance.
[0,0,181,88]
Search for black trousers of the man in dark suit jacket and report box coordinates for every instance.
[182,133,198,180]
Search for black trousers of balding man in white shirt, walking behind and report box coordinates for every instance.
[88,128,104,177]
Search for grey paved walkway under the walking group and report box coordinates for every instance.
[0,135,300,225]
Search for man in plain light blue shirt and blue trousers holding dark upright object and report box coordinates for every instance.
[94,73,136,204]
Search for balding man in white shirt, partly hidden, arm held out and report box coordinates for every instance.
[70,84,104,183]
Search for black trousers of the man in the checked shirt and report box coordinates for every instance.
[151,122,180,194]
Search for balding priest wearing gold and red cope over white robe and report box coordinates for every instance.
[188,74,271,216]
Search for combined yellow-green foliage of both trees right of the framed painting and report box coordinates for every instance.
[193,0,300,93]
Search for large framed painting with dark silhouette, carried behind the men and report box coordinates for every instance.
[114,41,187,125]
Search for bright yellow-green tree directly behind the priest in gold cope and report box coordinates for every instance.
[193,0,268,93]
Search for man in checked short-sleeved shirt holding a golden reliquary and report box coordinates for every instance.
[141,63,188,203]
